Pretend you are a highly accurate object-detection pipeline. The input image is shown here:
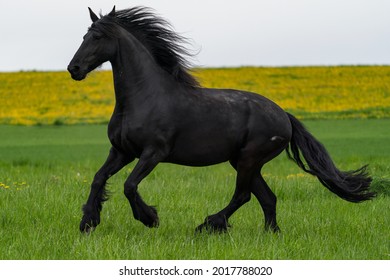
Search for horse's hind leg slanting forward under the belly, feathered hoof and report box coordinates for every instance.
[196,161,254,232]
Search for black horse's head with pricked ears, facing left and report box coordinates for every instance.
[68,6,116,81]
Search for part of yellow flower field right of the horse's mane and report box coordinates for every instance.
[199,66,390,118]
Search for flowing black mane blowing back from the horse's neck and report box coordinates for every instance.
[91,7,200,87]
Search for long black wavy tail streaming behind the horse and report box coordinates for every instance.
[286,113,375,202]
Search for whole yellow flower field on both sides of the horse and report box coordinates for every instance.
[0,66,390,125]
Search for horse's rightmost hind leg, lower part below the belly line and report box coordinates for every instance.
[251,174,280,232]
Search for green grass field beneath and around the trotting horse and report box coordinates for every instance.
[0,119,390,260]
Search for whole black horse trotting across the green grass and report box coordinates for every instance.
[68,7,374,232]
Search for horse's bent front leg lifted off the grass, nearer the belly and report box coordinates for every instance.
[124,149,164,227]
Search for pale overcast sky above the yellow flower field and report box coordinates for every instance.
[0,0,390,71]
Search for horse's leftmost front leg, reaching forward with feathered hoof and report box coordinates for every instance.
[80,147,134,233]
